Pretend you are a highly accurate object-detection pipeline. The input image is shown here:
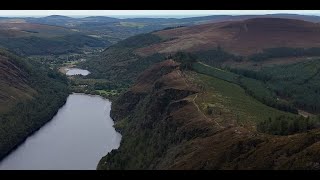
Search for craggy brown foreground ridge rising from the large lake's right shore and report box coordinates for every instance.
[98,60,320,169]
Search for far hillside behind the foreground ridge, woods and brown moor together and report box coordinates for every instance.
[80,18,320,114]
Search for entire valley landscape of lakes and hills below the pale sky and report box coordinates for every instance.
[0,11,320,170]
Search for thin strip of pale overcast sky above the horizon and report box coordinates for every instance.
[0,10,320,17]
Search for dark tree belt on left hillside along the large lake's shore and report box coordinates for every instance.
[0,52,69,159]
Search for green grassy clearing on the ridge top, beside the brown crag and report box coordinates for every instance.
[189,63,295,127]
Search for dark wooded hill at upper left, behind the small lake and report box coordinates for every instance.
[0,22,111,55]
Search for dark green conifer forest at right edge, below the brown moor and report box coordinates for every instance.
[231,59,320,113]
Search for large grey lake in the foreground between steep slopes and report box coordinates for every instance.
[0,94,121,170]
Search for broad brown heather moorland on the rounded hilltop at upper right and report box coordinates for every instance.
[136,18,320,56]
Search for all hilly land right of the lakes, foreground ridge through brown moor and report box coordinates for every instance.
[80,18,320,169]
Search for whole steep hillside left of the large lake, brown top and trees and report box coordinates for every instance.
[0,49,69,159]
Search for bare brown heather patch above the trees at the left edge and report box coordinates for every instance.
[0,52,35,112]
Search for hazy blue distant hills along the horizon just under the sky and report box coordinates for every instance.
[4,14,320,43]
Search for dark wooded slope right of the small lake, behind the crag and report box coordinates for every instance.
[78,34,165,87]
